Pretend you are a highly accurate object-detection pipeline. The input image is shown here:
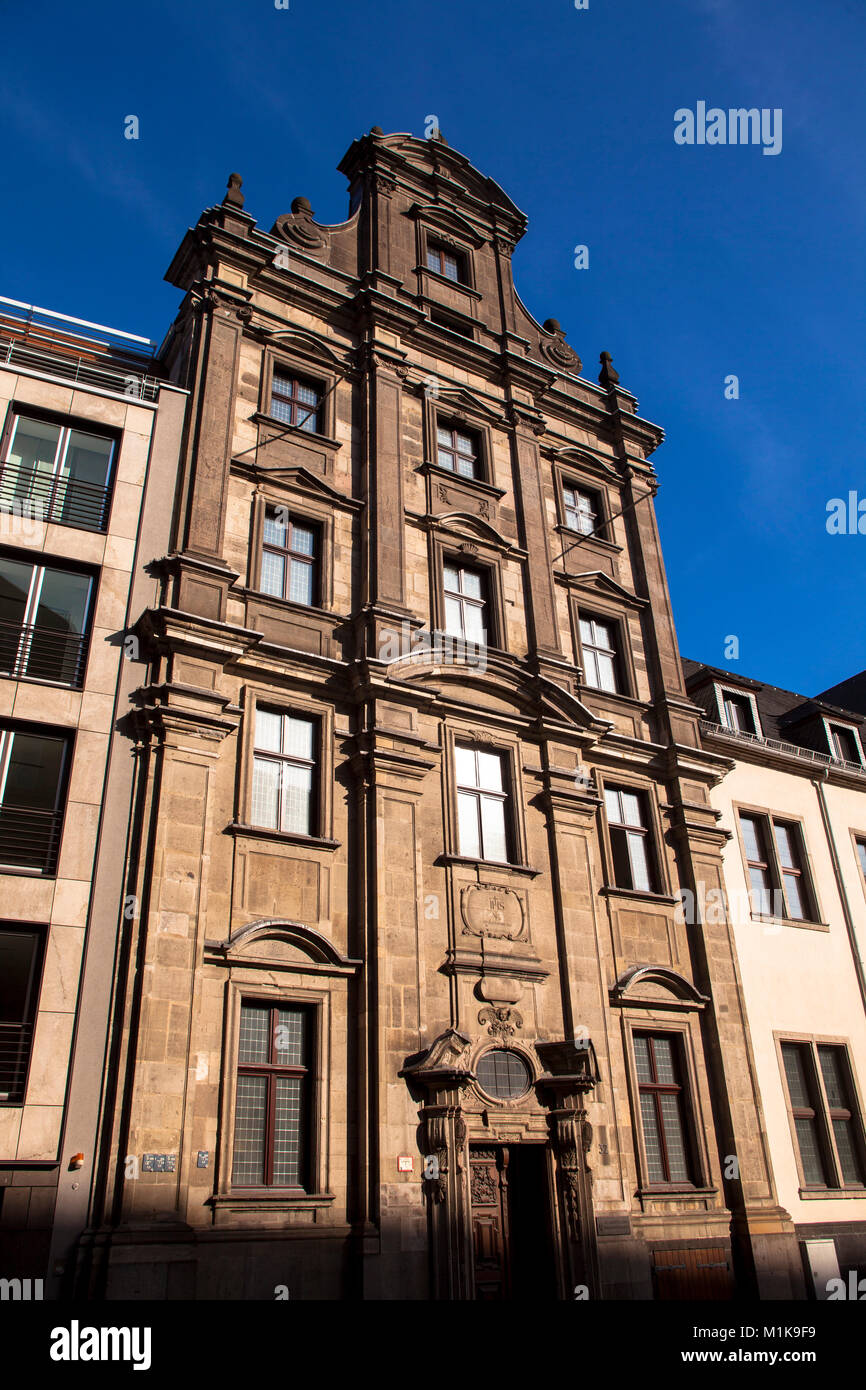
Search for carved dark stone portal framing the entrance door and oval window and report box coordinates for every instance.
[400,1029,598,1300]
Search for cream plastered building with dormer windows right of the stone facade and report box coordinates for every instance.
[684,662,866,1297]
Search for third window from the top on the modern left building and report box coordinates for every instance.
[0,726,70,874]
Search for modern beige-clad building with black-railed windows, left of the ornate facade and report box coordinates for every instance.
[0,299,186,1287]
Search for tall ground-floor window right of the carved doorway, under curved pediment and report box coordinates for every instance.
[634,1033,694,1186]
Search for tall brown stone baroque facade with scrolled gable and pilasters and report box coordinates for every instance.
[69,129,802,1298]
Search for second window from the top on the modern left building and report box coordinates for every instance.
[0,555,93,687]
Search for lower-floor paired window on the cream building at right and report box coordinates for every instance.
[781,1043,866,1187]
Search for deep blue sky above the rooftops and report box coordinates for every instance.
[0,0,866,694]
